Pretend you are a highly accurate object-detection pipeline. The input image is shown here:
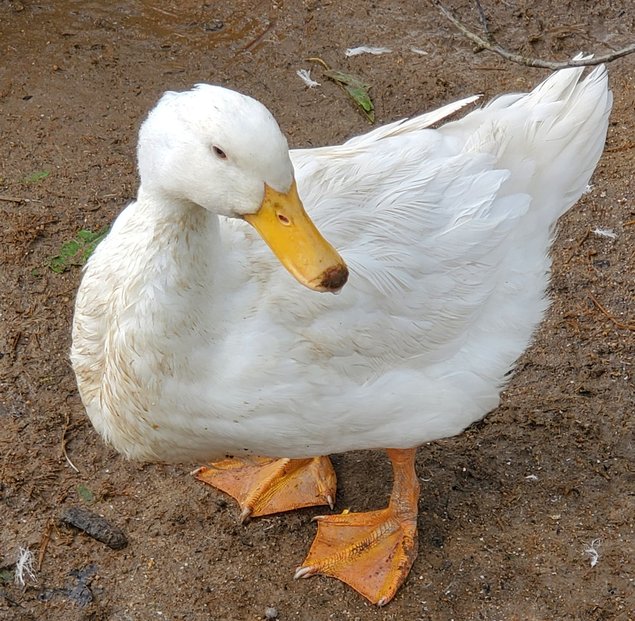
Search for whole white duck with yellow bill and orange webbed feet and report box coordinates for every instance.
[72,67,611,605]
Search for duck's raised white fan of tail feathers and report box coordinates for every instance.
[441,66,612,225]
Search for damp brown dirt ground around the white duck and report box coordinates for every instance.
[0,0,635,621]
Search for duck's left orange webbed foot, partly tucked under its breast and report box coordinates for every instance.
[194,457,336,522]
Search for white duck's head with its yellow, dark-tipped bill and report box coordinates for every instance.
[137,84,348,292]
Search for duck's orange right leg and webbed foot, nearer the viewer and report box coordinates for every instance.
[295,449,419,606]
